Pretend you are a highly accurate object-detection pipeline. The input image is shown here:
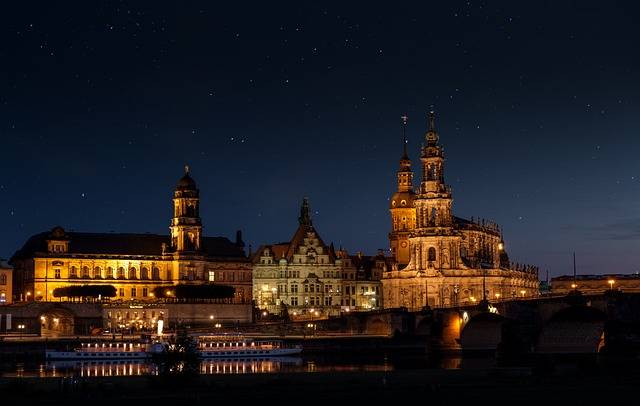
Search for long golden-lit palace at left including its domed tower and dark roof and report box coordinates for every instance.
[10,167,252,304]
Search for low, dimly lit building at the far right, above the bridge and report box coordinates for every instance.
[551,274,640,295]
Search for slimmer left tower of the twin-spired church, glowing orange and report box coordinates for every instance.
[389,116,416,268]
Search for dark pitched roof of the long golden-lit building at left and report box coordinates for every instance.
[10,232,245,262]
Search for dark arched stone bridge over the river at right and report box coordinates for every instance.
[304,291,640,354]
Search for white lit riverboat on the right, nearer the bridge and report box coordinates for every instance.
[198,336,302,358]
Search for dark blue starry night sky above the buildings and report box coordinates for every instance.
[0,1,640,278]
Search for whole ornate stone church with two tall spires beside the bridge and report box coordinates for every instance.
[382,112,538,310]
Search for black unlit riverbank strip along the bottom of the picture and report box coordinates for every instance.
[0,361,640,405]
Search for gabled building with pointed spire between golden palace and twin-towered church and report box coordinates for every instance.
[253,199,390,319]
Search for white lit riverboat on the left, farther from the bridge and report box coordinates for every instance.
[45,343,160,360]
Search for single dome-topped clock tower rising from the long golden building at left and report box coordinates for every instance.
[170,166,202,254]
